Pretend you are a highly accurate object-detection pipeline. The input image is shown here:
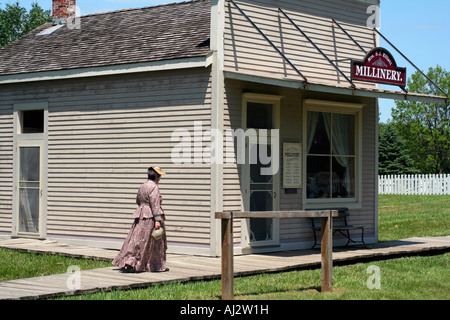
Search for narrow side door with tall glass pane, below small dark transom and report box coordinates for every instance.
[15,142,43,236]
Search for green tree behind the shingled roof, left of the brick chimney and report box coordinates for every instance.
[0,1,51,48]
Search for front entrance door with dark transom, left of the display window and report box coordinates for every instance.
[243,96,279,247]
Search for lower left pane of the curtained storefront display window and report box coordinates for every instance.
[306,156,330,199]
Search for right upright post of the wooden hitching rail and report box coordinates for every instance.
[321,211,333,292]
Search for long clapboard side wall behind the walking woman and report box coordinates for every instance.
[0,68,211,246]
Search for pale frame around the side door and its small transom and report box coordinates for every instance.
[12,102,48,239]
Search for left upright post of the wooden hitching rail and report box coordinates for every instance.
[222,213,234,300]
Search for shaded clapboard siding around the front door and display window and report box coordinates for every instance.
[223,79,378,248]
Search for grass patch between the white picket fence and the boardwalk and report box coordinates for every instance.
[378,195,450,241]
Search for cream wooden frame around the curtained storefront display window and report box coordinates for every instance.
[302,99,365,209]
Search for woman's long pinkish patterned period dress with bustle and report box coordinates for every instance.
[112,180,168,272]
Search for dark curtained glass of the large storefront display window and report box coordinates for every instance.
[306,111,356,199]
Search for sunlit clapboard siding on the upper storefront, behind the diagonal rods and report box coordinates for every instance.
[224,0,375,87]
